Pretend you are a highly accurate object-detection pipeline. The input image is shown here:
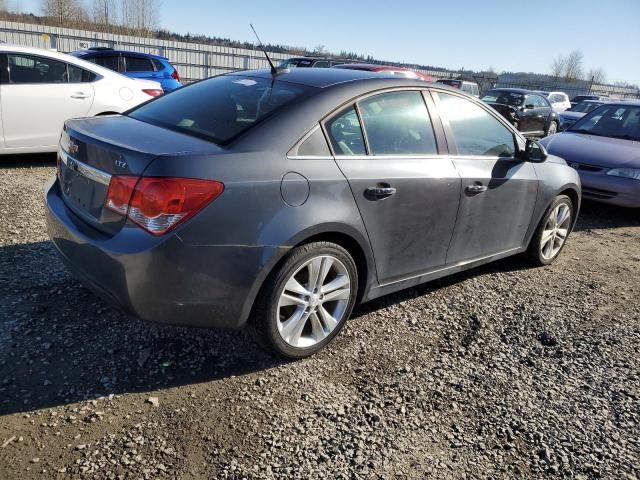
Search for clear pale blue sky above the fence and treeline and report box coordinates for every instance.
[7,0,640,85]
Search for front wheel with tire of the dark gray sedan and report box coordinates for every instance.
[527,195,573,266]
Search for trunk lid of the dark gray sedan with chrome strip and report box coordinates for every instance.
[58,115,222,235]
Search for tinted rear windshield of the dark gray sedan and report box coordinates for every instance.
[128,75,315,144]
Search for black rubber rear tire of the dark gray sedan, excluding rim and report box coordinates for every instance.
[249,242,358,360]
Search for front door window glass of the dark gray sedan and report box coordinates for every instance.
[437,92,516,157]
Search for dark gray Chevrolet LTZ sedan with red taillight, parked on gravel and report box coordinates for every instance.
[46,69,580,358]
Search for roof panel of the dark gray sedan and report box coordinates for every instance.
[225,68,444,91]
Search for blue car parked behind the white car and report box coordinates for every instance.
[70,47,182,92]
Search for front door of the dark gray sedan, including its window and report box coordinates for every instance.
[434,92,538,264]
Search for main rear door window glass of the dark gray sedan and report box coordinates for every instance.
[358,91,438,155]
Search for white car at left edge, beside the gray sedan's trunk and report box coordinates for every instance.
[0,45,164,154]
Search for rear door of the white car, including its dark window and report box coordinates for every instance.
[0,52,95,148]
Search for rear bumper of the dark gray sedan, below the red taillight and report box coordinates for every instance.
[46,178,282,328]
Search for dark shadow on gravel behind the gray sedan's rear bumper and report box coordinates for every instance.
[0,242,282,416]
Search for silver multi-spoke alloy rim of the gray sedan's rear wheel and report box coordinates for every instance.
[278,255,351,348]
